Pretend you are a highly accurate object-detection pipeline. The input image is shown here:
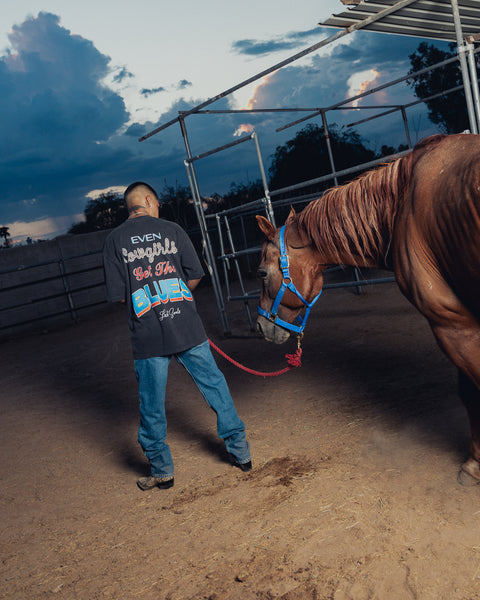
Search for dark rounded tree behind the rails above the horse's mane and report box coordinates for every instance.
[268,125,375,191]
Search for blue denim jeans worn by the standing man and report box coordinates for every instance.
[135,340,251,477]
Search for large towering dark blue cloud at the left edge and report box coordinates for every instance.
[0,13,128,222]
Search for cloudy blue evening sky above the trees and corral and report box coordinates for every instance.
[0,0,445,243]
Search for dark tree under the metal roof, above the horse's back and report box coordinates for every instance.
[407,42,469,133]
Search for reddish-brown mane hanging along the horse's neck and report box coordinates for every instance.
[296,135,445,266]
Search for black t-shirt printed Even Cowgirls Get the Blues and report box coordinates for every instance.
[103,216,207,359]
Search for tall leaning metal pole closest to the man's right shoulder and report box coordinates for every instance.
[179,118,230,334]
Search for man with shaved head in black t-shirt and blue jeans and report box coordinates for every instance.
[103,181,252,490]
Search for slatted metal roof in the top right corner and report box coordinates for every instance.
[320,0,480,42]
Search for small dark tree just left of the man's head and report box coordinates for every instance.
[68,192,128,233]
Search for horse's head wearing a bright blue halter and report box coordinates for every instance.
[257,208,327,344]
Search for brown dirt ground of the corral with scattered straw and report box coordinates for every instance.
[0,284,480,600]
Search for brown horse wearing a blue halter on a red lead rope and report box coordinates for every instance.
[257,134,480,484]
